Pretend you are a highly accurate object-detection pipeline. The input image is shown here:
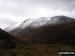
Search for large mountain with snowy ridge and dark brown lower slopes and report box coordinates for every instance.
[4,16,75,44]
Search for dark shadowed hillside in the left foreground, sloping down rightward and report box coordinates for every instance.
[0,29,18,48]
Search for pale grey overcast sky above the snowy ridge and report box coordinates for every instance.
[0,0,75,29]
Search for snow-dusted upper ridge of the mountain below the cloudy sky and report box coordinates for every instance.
[4,16,75,32]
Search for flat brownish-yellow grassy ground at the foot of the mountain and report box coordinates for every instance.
[0,44,75,56]
